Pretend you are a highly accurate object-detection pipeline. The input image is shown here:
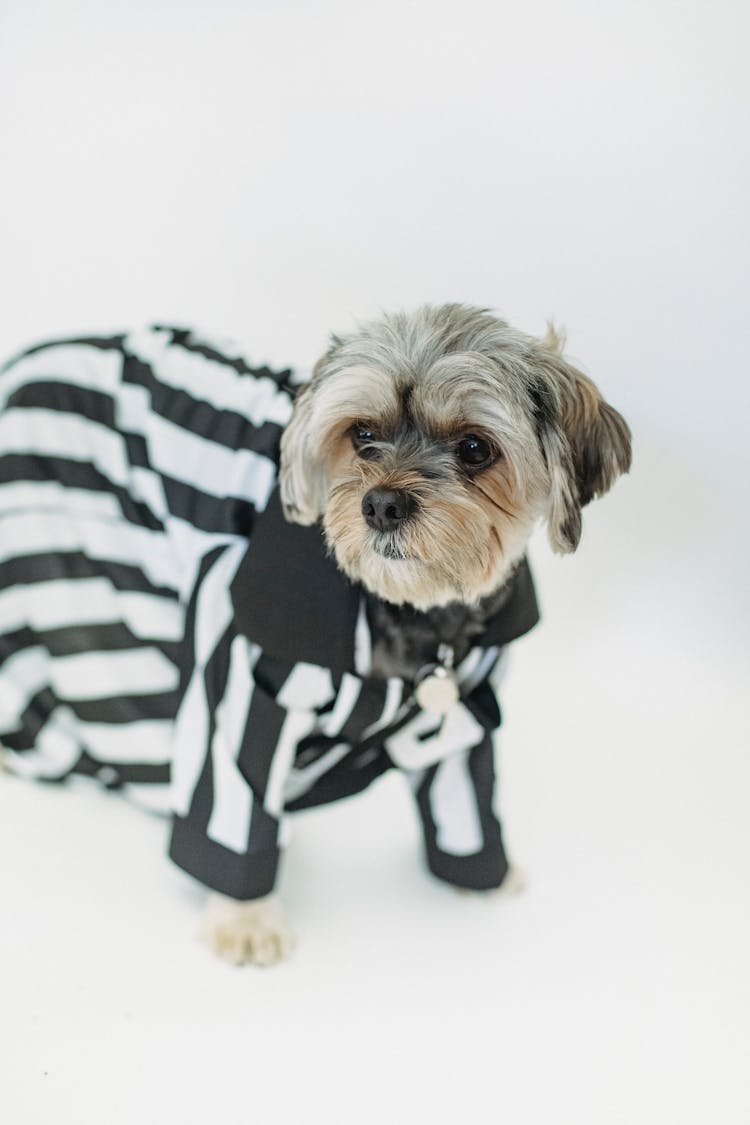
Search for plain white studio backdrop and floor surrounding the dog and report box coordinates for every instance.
[0,0,750,1125]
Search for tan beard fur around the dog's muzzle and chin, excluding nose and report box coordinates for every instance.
[324,476,534,610]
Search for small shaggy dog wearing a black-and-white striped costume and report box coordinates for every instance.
[0,304,631,964]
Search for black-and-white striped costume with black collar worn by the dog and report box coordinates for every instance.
[0,327,537,899]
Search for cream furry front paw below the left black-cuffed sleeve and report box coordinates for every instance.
[200,894,295,965]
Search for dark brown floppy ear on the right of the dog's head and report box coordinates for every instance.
[531,327,631,555]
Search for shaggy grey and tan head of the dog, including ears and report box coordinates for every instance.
[281,305,630,609]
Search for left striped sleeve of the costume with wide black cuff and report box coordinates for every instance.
[170,543,332,899]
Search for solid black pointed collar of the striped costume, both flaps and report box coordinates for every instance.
[232,488,539,676]
